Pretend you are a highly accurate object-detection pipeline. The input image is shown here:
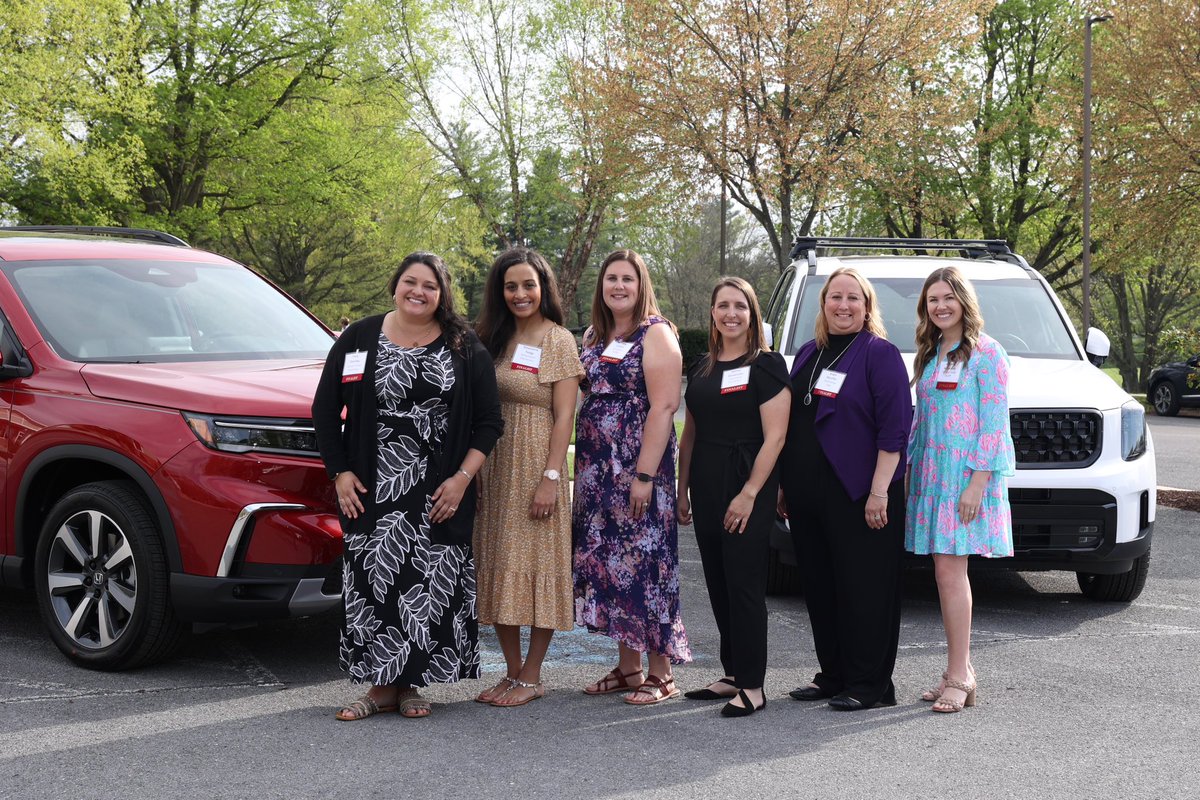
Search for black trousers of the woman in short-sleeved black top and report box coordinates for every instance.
[691,443,779,688]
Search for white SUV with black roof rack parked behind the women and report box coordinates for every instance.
[764,237,1156,602]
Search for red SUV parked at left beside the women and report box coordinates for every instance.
[0,228,342,669]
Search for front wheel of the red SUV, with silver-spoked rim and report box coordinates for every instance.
[35,481,182,669]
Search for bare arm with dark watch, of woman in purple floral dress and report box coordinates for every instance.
[629,325,683,517]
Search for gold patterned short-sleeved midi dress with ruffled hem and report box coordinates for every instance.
[474,325,583,631]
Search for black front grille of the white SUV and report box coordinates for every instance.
[1009,410,1103,469]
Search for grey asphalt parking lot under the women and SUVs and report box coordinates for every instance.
[0,509,1200,800]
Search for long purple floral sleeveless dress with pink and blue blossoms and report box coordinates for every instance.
[572,317,691,663]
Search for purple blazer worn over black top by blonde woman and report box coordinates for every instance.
[792,330,912,501]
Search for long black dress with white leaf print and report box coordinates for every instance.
[340,332,479,686]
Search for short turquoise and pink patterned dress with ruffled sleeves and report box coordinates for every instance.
[905,335,1016,558]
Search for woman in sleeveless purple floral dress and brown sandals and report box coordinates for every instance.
[572,249,691,705]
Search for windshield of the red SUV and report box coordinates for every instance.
[4,260,332,362]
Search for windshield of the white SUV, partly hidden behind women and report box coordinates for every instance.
[786,275,1080,360]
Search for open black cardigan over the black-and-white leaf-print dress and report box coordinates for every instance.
[312,314,504,545]
